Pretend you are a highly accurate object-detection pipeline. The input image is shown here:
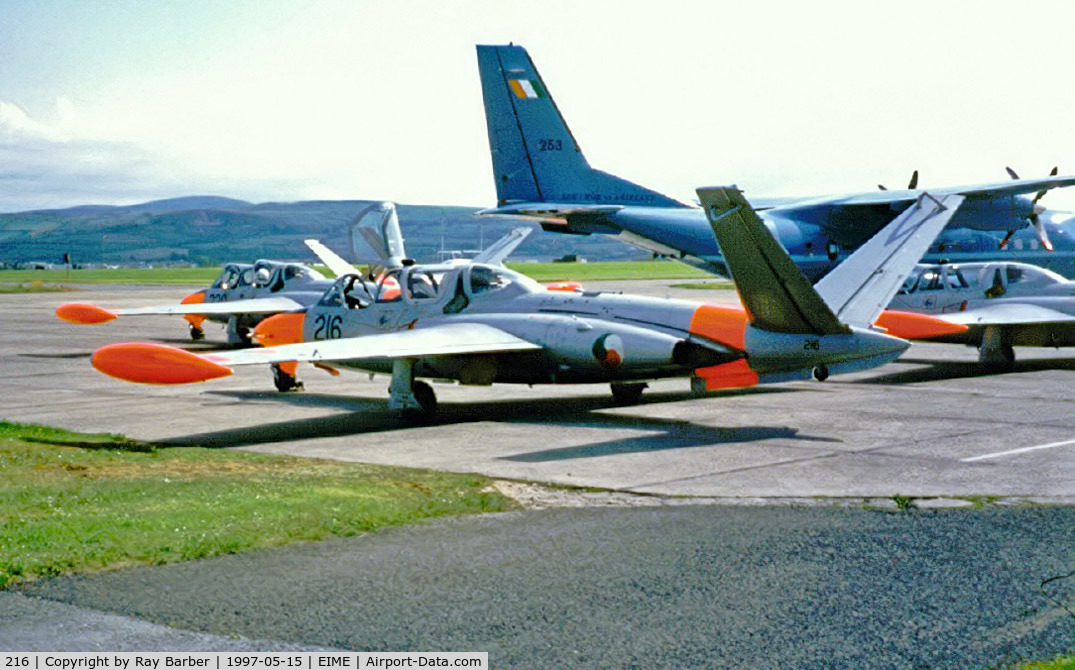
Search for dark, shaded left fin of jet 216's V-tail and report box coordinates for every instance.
[698,187,849,334]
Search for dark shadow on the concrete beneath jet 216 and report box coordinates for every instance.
[157,388,839,462]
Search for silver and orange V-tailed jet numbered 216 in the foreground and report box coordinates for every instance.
[92,188,962,413]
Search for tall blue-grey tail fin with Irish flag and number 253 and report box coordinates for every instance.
[477,45,687,208]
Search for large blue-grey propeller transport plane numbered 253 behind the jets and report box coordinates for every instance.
[477,45,1075,281]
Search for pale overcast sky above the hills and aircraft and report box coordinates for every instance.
[0,0,1075,212]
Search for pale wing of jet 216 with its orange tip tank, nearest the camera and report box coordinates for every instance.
[92,324,542,384]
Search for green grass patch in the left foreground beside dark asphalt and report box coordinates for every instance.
[0,422,515,588]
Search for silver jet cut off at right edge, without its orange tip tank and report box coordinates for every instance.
[891,262,1075,369]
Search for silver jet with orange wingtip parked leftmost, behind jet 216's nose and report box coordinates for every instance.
[56,260,332,346]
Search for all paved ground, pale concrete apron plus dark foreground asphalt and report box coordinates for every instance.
[0,282,1075,667]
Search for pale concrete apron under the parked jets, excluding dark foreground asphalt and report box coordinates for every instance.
[0,282,1075,502]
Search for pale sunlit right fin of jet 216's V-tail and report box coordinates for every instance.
[814,194,964,326]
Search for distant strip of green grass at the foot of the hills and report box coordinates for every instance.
[0,260,713,287]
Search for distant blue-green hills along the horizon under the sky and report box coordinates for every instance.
[0,196,642,263]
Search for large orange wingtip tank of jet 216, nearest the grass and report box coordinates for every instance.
[90,342,231,384]
